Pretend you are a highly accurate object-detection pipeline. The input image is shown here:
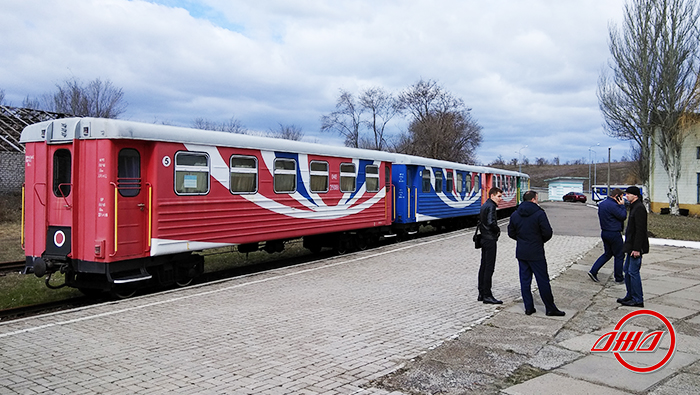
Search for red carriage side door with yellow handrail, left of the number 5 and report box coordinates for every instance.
[113,143,150,257]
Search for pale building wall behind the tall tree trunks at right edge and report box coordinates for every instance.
[649,122,700,215]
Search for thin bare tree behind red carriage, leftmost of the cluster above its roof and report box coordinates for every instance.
[321,89,364,148]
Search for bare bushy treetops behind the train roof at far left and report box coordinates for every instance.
[45,78,127,118]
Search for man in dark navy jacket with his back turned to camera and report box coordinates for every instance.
[508,191,566,316]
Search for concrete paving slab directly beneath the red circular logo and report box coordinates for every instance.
[555,352,698,392]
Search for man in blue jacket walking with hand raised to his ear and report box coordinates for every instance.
[588,188,627,283]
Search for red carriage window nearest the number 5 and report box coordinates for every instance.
[175,152,209,195]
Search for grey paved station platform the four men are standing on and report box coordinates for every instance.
[0,205,700,394]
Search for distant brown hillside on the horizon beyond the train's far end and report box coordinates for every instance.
[489,162,638,190]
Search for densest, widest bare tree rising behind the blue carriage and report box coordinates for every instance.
[397,80,482,163]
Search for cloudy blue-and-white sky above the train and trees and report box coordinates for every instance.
[0,0,629,163]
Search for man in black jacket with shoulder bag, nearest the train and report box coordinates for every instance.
[477,187,503,304]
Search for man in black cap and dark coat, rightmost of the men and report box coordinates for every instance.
[617,186,649,307]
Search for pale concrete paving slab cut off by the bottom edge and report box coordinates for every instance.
[501,373,627,395]
